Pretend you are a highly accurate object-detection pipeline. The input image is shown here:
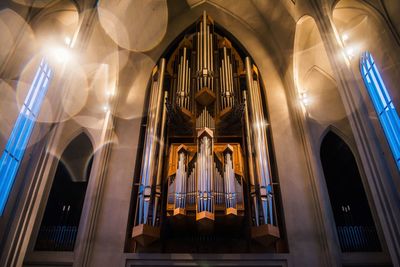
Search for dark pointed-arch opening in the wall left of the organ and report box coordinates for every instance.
[35,133,93,251]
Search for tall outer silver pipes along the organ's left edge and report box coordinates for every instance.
[136,59,165,225]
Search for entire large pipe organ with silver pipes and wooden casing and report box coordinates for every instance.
[132,12,280,252]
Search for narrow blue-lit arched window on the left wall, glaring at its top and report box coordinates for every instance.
[0,59,52,216]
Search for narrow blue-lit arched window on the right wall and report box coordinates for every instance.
[360,52,400,169]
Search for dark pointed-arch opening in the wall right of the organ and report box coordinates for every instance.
[320,132,381,252]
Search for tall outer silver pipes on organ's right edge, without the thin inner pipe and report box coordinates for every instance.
[246,57,276,225]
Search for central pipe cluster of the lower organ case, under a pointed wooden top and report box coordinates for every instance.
[197,135,214,213]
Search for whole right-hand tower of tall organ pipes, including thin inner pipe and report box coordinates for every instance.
[243,57,276,226]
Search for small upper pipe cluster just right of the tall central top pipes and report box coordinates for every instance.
[219,46,233,110]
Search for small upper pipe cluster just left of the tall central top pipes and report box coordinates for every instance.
[176,47,191,111]
